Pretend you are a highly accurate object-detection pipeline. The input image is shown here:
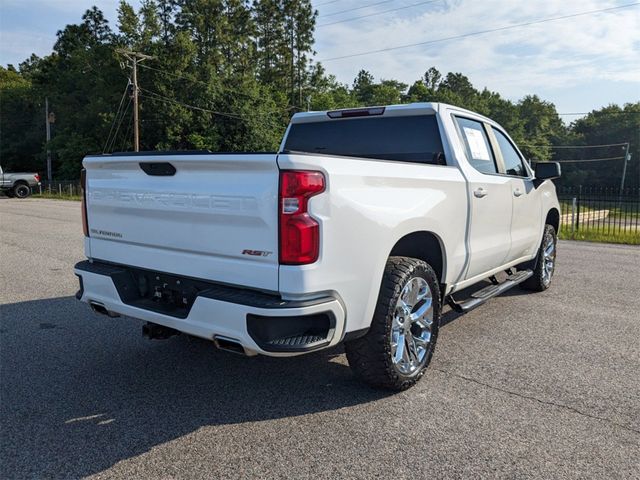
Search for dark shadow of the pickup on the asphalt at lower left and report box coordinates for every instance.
[0,297,386,478]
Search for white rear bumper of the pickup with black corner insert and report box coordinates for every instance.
[75,261,345,357]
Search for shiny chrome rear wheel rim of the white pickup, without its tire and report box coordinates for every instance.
[391,277,433,375]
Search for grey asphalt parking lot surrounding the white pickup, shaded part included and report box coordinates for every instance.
[0,198,640,479]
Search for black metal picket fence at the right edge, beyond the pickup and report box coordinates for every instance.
[558,186,640,237]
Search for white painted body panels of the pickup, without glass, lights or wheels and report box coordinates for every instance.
[76,104,559,356]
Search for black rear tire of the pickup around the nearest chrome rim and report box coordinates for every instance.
[345,257,441,391]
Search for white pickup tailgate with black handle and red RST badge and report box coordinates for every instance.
[83,153,278,291]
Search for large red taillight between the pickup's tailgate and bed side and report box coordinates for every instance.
[279,170,324,265]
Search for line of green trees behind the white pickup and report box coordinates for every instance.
[0,0,640,186]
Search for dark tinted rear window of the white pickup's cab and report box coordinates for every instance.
[284,115,444,164]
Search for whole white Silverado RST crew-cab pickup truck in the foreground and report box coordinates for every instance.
[75,103,560,390]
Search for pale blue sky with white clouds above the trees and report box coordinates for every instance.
[0,0,640,122]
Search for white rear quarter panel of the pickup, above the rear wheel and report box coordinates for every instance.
[278,154,467,331]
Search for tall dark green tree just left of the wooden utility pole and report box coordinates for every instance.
[36,7,122,179]
